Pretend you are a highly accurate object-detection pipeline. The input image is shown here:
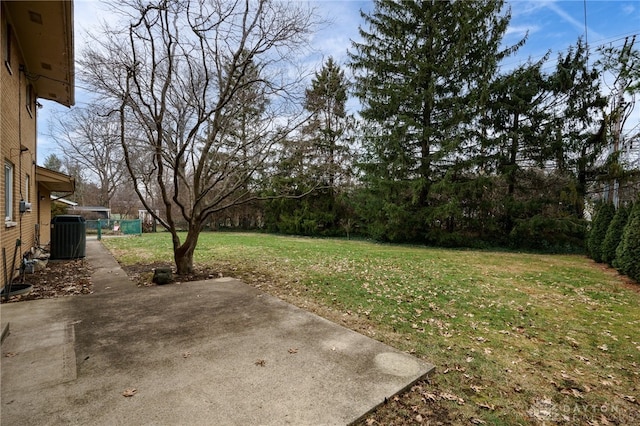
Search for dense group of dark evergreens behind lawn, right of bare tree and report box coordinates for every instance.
[266,0,640,255]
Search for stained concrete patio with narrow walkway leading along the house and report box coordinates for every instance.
[0,240,433,425]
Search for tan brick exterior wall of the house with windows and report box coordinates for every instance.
[0,3,38,285]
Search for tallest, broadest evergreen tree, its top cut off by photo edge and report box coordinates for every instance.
[349,0,512,240]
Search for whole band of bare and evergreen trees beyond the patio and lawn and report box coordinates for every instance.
[46,0,640,273]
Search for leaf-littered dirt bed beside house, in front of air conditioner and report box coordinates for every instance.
[2,259,93,303]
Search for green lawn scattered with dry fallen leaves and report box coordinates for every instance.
[103,233,640,425]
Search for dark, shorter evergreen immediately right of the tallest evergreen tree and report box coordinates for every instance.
[480,59,551,242]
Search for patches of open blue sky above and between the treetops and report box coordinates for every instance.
[38,0,640,164]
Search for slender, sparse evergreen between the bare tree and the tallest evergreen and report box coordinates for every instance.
[265,58,354,235]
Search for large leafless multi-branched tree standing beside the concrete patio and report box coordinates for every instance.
[81,0,315,274]
